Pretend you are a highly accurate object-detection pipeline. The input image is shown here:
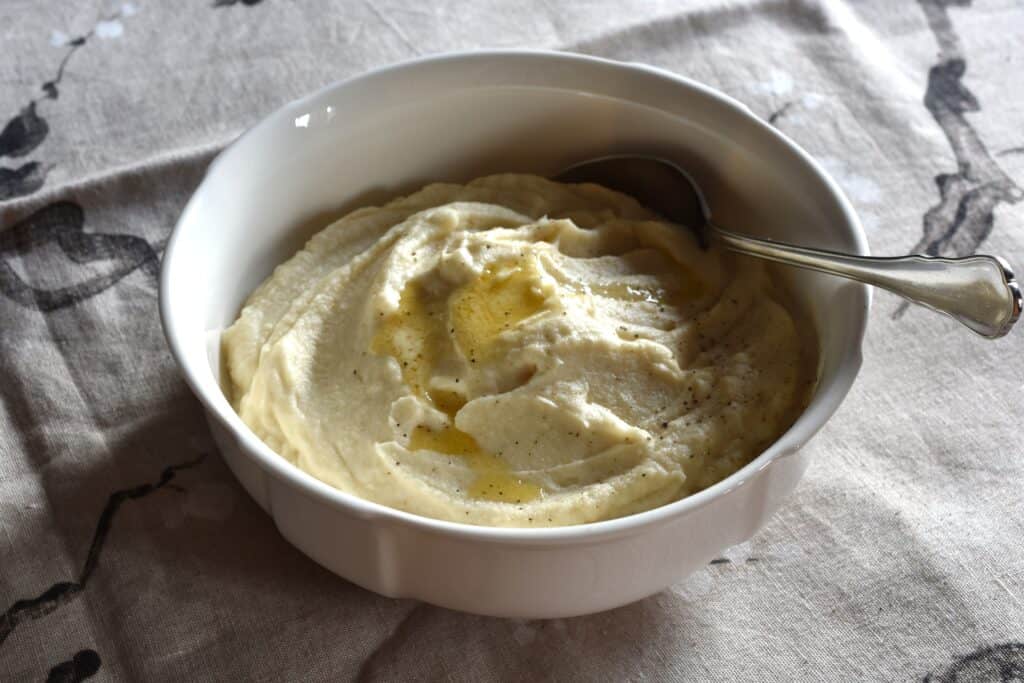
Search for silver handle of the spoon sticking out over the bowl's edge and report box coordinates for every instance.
[710,225,1021,339]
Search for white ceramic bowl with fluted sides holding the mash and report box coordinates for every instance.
[160,51,869,617]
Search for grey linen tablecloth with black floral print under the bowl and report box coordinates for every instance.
[0,0,1024,681]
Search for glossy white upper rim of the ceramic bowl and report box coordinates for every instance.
[159,49,871,546]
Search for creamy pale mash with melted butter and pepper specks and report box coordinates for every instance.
[222,174,816,526]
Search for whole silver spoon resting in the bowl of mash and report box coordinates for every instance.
[555,155,1022,339]
